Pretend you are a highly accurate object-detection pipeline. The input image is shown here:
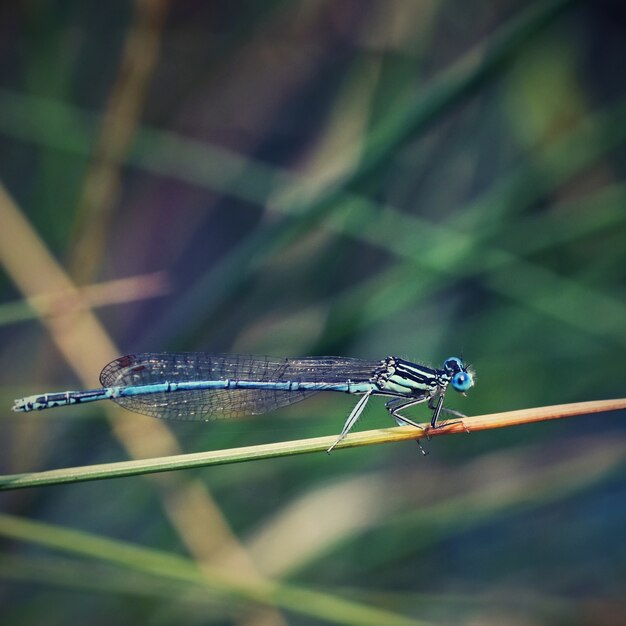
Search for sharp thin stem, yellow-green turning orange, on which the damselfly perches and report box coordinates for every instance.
[0,398,626,490]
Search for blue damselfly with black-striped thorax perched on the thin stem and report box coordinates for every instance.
[13,352,474,452]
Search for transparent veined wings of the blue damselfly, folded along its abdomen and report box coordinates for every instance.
[100,352,379,420]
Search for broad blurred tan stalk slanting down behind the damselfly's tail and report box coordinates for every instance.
[0,172,281,625]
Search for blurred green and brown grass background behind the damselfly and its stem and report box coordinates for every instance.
[0,0,626,626]
